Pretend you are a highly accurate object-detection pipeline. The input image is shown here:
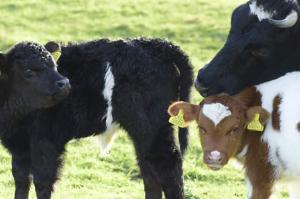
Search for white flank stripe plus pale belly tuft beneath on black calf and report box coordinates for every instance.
[98,62,118,156]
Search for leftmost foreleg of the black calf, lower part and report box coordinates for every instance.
[12,152,30,199]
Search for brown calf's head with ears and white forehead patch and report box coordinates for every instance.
[168,95,269,170]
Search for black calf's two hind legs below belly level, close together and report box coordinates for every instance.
[130,127,184,199]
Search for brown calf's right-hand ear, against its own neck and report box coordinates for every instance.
[246,106,270,125]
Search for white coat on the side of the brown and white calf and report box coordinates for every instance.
[256,72,300,180]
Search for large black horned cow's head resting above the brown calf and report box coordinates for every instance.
[195,0,300,96]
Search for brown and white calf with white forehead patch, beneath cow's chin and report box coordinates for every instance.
[168,72,300,199]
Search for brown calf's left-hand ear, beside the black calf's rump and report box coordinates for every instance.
[168,101,200,123]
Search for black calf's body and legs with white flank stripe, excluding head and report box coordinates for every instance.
[3,39,193,199]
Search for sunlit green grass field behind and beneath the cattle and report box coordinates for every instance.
[0,0,287,199]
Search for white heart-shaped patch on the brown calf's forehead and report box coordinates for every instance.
[202,103,231,126]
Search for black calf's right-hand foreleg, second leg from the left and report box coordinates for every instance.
[31,140,61,199]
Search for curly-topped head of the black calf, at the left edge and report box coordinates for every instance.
[0,42,70,109]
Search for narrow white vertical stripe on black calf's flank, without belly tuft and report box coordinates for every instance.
[102,62,115,129]
